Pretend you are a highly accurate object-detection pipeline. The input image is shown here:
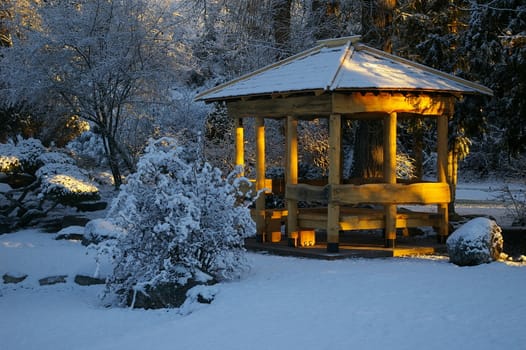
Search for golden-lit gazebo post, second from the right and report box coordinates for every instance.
[384,112,397,248]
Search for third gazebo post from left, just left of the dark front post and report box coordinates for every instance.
[285,116,298,247]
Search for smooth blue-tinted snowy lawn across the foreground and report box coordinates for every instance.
[0,230,526,350]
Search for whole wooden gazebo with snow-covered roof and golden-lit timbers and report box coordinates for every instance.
[196,36,492,253]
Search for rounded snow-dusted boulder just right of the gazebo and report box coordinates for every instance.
[446,217,504,266]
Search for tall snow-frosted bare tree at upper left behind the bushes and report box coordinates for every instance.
[1,0,192,186]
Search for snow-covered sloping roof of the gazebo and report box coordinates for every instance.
[196,37,493,102]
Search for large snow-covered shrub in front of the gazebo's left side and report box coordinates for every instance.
[102,138,255,307]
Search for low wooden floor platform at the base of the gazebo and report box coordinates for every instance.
[245,233,446,260]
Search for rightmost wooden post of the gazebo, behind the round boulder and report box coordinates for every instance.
[437,115,449,243]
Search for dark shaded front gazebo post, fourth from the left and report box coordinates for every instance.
[327,114,342,253]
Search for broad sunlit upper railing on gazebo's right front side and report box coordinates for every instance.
[327,182,451,205]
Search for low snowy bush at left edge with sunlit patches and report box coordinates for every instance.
[0,138,99,230]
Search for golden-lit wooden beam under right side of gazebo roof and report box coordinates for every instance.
[332,92,455,115]
